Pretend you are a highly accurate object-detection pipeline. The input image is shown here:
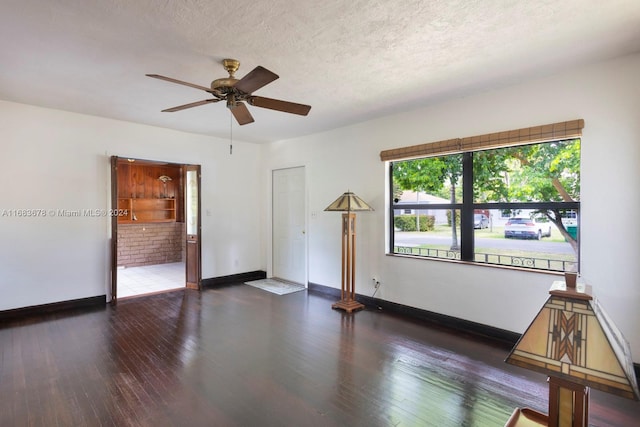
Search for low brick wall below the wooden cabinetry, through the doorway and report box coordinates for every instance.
[118,222,186,267]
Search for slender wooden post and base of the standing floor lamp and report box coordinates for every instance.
[331,212,364,313]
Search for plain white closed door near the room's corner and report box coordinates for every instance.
[273,167,307,285]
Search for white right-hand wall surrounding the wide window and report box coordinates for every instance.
[263,55,640,362]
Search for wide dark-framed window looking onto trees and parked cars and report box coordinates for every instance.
[389,138,581,271]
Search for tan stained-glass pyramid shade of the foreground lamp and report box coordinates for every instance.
[506,292,640,400]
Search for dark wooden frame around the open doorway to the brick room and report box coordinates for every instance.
[110,156,202,305]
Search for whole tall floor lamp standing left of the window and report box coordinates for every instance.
[325,191,373,313]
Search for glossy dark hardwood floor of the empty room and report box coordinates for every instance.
[0,285,640,427]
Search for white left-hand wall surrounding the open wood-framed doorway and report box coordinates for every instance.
[0,101,266,310]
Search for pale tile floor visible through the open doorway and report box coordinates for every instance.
[118,262,185,298]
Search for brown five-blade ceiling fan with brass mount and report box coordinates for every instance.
[147,59,311,125]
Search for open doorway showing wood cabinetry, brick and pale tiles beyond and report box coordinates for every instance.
[111,156,201,303]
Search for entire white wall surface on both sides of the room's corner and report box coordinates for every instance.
[0,51,640,362]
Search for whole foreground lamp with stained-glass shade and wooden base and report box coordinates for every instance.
[505,281,640,426]
